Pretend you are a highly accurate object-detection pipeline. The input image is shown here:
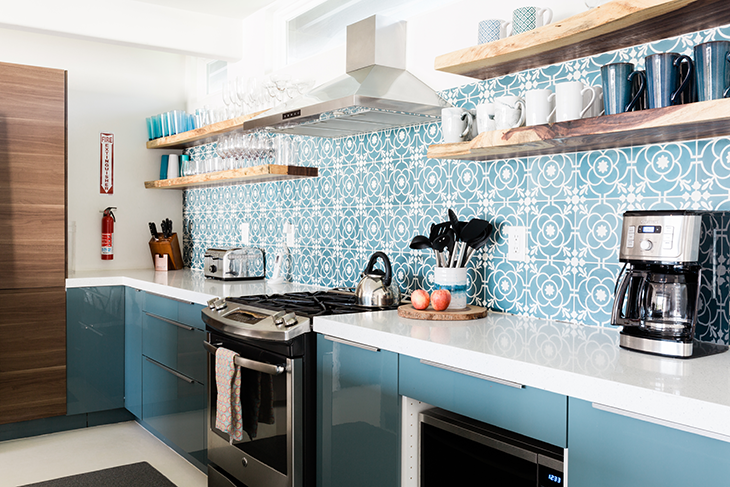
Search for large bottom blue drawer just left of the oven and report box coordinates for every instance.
[142,359,207,465]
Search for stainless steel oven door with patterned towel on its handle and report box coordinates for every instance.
[205,333,303,487]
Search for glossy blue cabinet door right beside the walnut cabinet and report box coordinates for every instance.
[66,286,124,415]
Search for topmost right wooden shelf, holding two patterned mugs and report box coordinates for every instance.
[435,0,730,79]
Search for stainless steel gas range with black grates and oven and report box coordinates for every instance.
[203,290,397,487]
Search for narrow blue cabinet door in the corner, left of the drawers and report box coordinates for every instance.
[124,287,145,418]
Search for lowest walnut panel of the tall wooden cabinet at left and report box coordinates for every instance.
[0,365,66,424]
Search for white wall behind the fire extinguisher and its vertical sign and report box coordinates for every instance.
[0,29,186,272]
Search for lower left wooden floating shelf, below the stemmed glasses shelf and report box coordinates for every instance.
[144,164,319,189]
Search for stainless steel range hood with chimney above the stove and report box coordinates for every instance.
[243,16,450,137]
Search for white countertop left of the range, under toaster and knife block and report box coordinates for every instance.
[66,268,321,304]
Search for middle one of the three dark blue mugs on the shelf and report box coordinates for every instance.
[644,52,694,108]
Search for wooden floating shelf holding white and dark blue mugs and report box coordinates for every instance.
[428,98,730,161]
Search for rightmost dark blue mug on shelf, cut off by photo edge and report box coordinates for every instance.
[694,41,730,101]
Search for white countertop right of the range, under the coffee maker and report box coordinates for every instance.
[314,311,730,441]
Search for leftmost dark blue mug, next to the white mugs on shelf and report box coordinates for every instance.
[601,63,646,115]
